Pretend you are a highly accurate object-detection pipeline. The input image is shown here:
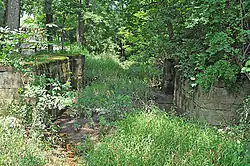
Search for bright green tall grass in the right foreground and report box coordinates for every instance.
[85,111,250,166]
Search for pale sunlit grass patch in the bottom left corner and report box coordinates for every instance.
[0,117,46,166]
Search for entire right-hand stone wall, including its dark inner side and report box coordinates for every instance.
[163,59,250,125]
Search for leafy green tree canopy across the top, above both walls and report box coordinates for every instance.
[0,0,250,88]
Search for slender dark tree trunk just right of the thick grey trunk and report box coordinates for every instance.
[45,0,53,51]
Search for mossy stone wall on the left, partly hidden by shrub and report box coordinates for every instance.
[0,55,85,113]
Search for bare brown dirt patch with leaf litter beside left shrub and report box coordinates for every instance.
[47,110,100,166]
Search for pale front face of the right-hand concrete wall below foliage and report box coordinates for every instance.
[188,80,250,125]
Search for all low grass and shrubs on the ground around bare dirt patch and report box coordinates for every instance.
[0,50,250,166]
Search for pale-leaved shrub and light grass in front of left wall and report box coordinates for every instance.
[0,76,74,166]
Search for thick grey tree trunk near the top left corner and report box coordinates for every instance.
[7,0,20,30]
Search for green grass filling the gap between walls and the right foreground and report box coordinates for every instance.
[74,52,250,166]
